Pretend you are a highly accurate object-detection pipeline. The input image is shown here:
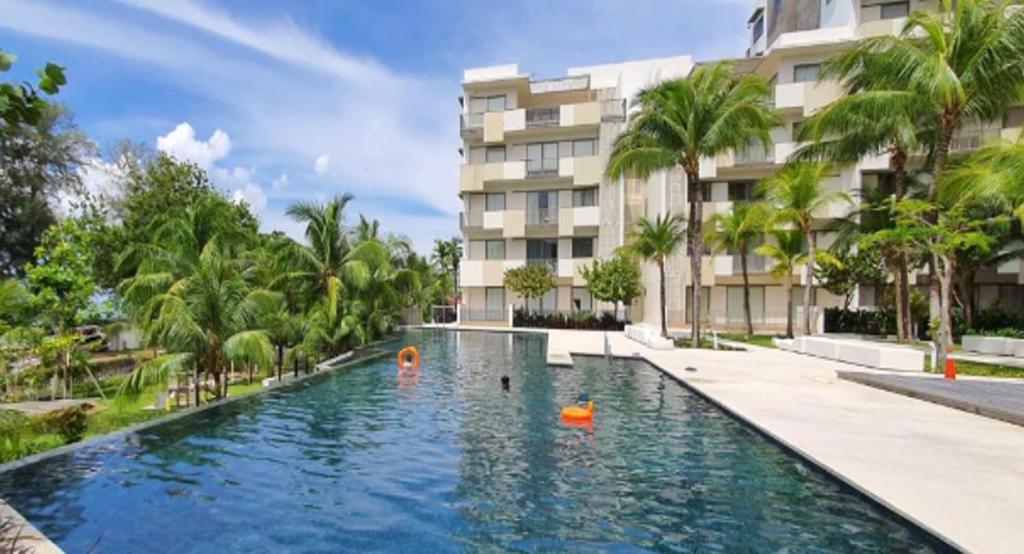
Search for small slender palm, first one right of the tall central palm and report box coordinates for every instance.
[707,202,766,335]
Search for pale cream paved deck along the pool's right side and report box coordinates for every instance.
[548,331,1024,554]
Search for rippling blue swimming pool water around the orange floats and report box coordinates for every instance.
[0,331,942,554]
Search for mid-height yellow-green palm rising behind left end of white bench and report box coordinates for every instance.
[759,162,852,335]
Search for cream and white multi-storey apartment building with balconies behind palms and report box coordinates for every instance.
[460,0,1024,331]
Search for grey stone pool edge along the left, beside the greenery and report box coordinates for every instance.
[0,344,395,554]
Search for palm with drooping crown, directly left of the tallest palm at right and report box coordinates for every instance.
[792,90,935,341]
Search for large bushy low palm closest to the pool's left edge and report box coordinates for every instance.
[121,246,281,403]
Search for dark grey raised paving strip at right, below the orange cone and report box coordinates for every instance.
[839,372,1024,426]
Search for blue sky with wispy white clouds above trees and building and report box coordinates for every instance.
[0,0,750,251]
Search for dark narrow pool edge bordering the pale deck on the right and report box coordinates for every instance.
[430,328,970,553]
